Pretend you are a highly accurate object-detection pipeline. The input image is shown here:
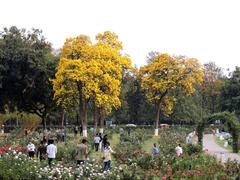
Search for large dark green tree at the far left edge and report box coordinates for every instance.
[0,26,58,126]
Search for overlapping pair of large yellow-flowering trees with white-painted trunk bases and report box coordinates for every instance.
[53,31,131,136]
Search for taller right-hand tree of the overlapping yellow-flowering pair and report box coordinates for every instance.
[94,31,133,133]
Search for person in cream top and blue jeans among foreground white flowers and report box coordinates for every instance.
[103,142,114,171]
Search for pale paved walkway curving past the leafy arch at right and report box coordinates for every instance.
[203,134,240,162]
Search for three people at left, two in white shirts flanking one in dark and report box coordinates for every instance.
[27,139,57,166]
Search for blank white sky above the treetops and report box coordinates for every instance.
[0,0,240,70]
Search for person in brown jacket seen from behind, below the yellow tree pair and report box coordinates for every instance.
[75,139,88,166]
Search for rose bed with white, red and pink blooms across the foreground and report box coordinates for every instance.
[0,128,240,180]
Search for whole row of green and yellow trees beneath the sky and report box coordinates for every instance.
[0,26,240,135]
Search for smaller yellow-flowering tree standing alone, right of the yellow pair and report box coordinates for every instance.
[139,53,203,136]
